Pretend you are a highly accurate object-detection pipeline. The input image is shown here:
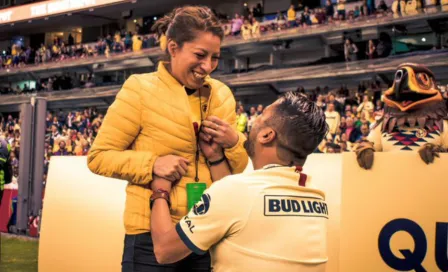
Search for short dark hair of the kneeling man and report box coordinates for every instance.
[266,92,328,166]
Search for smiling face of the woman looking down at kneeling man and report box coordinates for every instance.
[168,32,221,89]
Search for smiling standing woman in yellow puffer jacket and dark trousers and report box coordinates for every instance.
[88,6,248,271]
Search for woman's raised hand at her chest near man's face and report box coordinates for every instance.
[201,116,239,148]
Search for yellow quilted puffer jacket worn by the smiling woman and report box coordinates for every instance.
[88,62,248,234]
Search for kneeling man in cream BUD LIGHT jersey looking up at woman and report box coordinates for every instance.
[150,92,329,272]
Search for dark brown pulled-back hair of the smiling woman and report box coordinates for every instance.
[151,6,224,47]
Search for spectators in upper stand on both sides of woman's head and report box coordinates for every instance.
[0,0,402,69]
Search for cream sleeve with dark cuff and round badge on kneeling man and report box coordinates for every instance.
[176,175,252,255]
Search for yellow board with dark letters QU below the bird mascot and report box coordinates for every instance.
[339,152,448,272]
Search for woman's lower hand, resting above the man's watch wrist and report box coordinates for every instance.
[152,155,190,182]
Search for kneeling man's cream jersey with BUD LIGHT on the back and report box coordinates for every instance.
[176,165,329,272]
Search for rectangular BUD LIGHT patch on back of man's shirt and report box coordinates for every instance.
[264,195,328,219]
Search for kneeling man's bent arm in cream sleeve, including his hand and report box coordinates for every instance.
[151,177,250,264]
